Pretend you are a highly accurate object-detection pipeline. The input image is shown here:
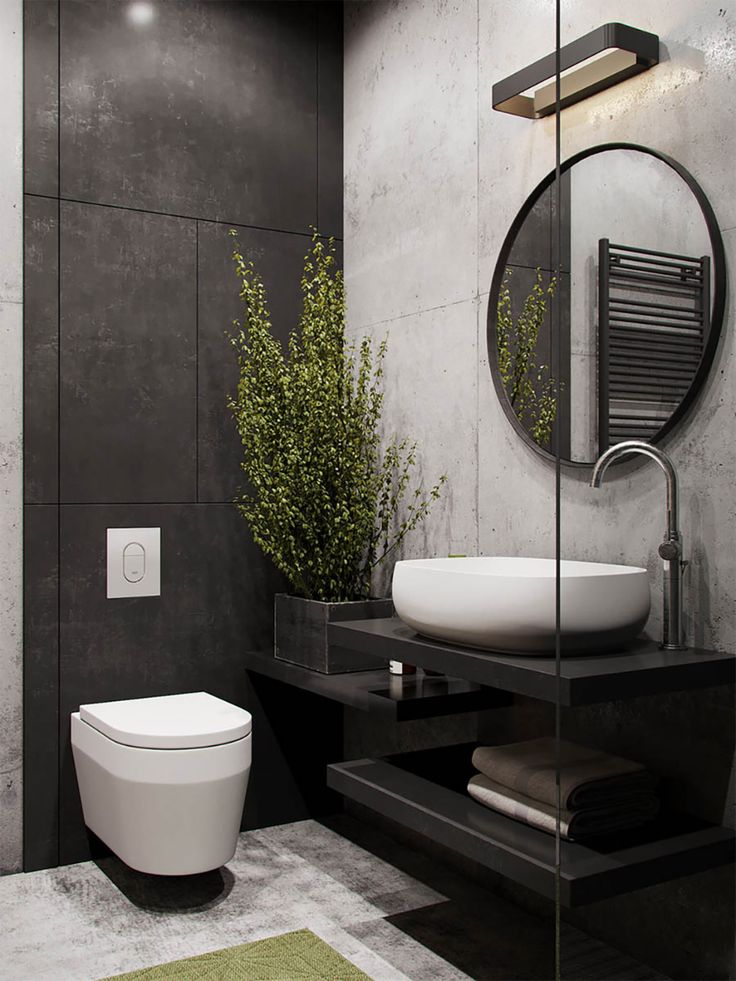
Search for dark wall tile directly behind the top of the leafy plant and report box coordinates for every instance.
[198,222,311,501]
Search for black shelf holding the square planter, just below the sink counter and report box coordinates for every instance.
[245,651,511,722]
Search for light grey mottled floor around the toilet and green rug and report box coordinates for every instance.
[0,821,455,981]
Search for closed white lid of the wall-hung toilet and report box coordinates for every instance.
[79,691,252,749]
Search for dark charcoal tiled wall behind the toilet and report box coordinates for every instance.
[25,0,342,869]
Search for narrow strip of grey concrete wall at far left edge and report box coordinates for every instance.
[0,0,23,873]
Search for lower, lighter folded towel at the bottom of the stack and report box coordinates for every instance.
[468,773,659,841]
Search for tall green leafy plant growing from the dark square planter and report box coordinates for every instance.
[228,231,446,602]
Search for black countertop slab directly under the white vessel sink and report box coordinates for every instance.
[329,617,736,706]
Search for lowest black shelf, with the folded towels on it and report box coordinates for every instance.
[327,745,736,906]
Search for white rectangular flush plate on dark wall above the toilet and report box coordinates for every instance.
[107,528,161,599]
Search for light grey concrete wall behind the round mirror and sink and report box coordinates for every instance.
[345,0,736,979]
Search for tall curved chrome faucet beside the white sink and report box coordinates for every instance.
[590,439,687,651]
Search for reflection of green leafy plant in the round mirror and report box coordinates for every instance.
[496,268,558,446]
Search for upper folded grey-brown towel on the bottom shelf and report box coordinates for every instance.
[473,736,657,811]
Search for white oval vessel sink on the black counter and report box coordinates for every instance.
[393,556,649,654]
